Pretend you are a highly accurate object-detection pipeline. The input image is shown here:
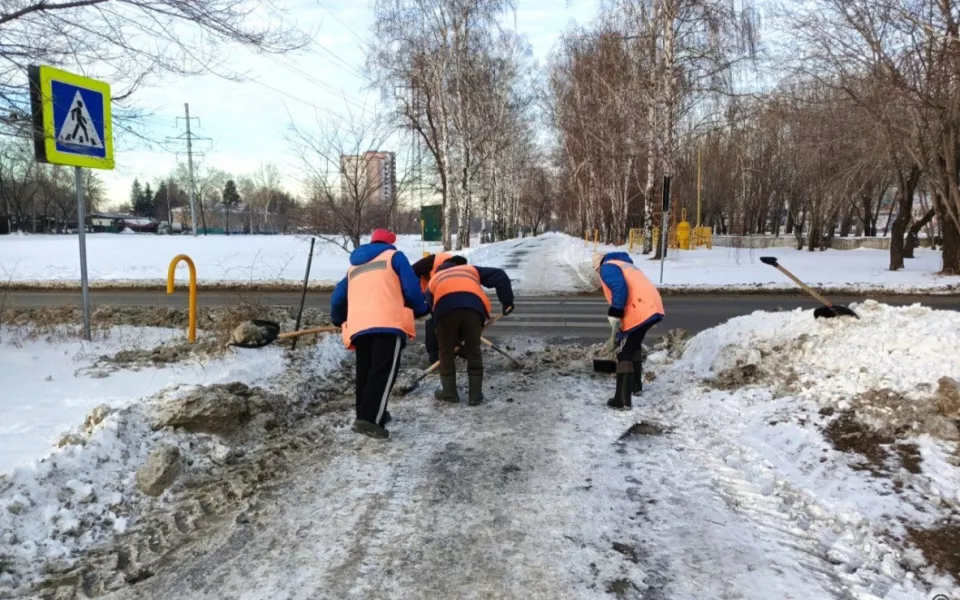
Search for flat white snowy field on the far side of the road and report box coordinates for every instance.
[0,234,960,295]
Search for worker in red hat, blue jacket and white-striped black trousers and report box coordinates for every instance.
[330,229,429,439]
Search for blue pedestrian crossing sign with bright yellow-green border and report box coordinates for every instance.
[29,66,114,169]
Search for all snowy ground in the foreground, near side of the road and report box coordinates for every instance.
[0,302,960,600]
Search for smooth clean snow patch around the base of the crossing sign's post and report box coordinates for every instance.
[0,327,284,473]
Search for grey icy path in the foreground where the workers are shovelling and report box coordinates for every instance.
[101,365,848,600]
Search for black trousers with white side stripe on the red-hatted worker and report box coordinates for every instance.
[353,333,403,425]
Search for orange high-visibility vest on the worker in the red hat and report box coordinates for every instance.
[342,250,417,350]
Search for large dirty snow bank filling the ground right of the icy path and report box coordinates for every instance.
[645,301,960,599]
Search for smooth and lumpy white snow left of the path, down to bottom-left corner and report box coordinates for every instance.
[0,327,345,598]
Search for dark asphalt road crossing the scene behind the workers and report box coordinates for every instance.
[5,290,960,341]
